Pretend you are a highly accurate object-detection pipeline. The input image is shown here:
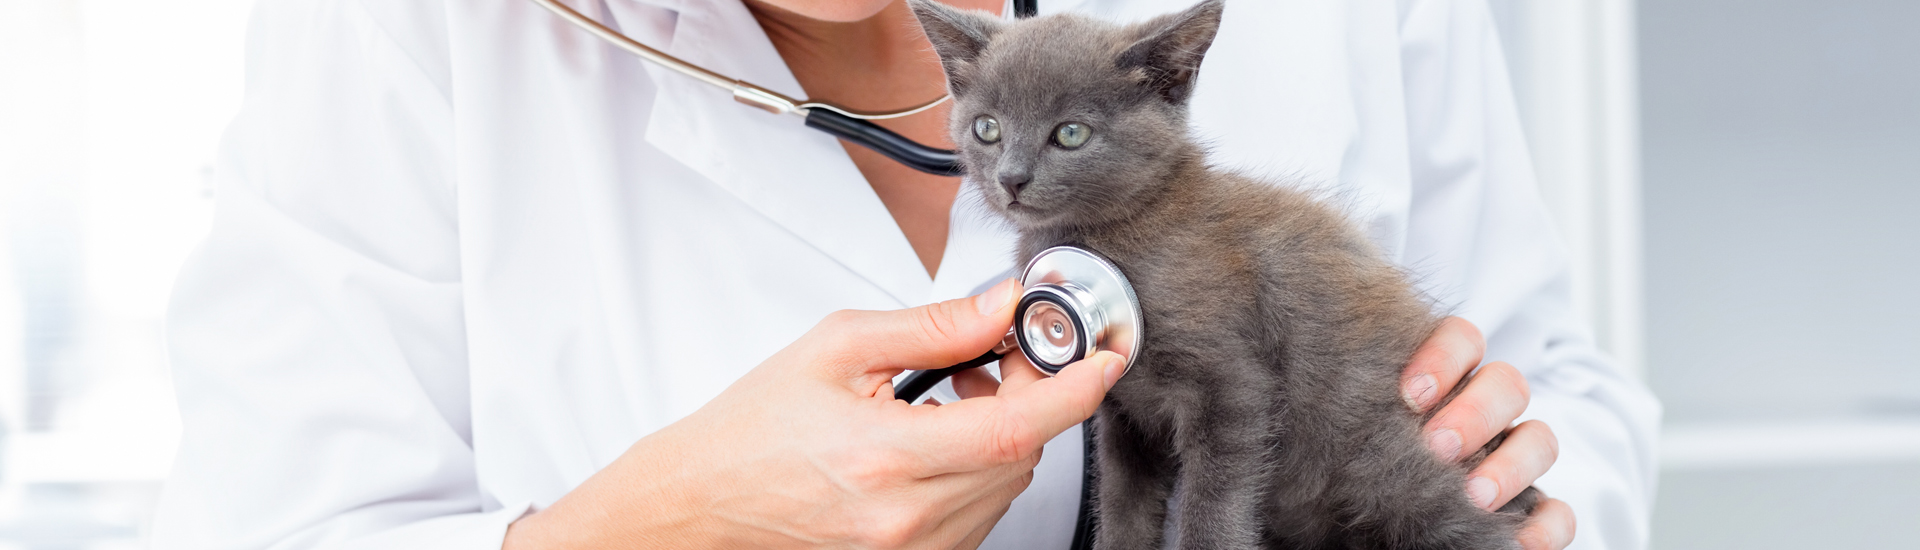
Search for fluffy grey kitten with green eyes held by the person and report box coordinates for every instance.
[910,0,1538,548]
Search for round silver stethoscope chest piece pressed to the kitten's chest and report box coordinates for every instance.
[1014,246,1142,375]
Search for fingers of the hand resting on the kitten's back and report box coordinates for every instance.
[1400,317,1574,550]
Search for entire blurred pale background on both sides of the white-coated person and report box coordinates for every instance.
[0,0,1920,550]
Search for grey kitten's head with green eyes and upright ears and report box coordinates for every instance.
[908,0,1221,229]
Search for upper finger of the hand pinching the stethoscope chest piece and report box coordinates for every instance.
[814,279,1020,381]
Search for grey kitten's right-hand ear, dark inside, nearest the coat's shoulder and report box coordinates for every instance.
[1119,0,1225,104]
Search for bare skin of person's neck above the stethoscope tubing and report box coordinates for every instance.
[747,0,1002,112]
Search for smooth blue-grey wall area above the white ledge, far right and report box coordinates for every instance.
[1644,0,1920,421]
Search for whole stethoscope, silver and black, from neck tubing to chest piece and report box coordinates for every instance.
[532,0,1142,550]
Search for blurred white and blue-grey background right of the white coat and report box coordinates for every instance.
[1490,0,1920,548]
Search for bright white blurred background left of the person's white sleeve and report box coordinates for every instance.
[0,0,252,550]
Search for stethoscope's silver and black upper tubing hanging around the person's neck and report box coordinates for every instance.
[534,0,1041,175]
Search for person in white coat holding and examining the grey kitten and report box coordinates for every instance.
[154,0,1659,548]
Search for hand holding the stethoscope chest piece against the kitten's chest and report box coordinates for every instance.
[505,281,1123,548]
